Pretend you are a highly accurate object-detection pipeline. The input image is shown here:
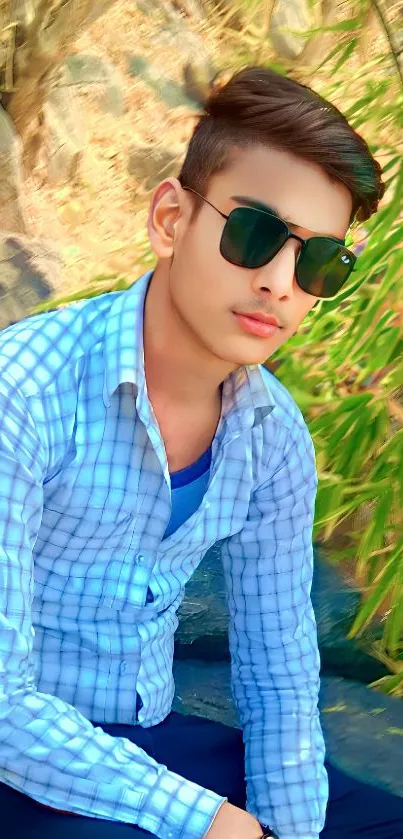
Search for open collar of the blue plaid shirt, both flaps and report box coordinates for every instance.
[103,270,275,430]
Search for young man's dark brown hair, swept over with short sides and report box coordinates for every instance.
[179,67,385,224]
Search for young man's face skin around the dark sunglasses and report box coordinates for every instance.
[148,146,352,366]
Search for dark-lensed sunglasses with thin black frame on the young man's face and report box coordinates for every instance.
[183,186,357,298]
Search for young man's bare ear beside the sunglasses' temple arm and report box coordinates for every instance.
[147,178,183,259]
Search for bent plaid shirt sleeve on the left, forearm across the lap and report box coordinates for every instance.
[0,373,226,839]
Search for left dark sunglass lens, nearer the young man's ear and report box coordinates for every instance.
[220,207,287,268]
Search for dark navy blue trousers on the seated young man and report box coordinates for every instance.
[0,712,403,839]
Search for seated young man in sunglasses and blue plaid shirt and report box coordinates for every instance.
[0,68,403,839]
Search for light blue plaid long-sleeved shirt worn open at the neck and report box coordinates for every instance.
[0,272,328,839]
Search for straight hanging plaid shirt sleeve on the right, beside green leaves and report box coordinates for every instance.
[222,421,328,839]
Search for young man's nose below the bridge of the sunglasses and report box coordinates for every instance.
[252,239,299,300]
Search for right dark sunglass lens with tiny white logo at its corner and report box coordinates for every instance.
[296,237,356,297]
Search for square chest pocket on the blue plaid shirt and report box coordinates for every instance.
[34,501,135,607]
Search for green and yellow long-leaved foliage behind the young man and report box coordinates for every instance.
[31,0,403,696]
